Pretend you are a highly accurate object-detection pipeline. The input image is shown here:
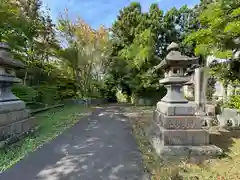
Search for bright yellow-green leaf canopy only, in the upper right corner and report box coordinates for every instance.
[185,0,240,58]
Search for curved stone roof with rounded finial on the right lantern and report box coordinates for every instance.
[158,42,199,69]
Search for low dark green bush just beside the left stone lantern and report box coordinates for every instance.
[12,84,37,102]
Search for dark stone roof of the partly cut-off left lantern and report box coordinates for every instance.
[0,43,25,69]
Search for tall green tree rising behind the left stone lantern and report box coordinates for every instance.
[0,0,61,85]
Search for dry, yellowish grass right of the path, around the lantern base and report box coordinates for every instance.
[126,107,240,180]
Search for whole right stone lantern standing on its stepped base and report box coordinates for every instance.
[149,43,222,156]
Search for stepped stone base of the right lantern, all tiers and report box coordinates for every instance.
[147,107,222,156]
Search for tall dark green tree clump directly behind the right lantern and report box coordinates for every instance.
[107,3,192,97]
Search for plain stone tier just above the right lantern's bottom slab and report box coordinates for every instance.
[155,126,209,146]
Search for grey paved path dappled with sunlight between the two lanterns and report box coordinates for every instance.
[0,106,147,180]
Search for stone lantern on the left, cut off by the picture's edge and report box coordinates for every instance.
[0,43,35,141]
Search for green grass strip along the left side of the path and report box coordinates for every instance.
[0,105,91,172]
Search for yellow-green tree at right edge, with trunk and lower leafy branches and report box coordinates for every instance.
[185,0,240,105]
